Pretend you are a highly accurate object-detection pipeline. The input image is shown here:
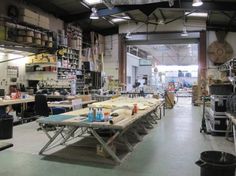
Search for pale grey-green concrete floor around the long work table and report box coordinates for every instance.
[0,99,234,176]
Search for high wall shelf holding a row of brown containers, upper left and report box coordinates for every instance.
[0,17,55,52]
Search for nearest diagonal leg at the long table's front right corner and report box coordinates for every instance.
[90,128,121,163]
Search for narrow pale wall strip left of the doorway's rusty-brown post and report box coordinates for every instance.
[104,34,119,79]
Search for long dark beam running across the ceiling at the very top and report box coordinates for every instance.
[61,0,236,22]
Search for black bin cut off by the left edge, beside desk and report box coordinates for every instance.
[0,114,13,139]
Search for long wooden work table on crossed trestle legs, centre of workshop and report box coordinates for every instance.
[37,97,166,163]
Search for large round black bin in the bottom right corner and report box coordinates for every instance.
[196,151,236,176]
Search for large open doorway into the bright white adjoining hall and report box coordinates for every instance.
[126,43,199,102]
